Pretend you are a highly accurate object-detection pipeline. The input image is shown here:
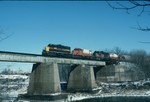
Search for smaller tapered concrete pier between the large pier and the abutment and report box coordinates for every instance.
[67,65,97,91]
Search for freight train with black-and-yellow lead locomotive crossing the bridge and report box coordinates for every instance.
[42,44,125,64]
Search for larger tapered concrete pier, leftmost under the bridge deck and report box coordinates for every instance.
[27,63,61,95]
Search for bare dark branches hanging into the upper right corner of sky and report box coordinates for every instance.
[106,0,150,31]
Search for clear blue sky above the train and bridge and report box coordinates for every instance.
[0,1,150,71]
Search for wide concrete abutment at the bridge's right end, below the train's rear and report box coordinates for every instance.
[95,62,144,83]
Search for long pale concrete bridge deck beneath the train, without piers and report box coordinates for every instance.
[0,51,105,66]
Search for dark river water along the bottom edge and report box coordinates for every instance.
[0,96,150,102]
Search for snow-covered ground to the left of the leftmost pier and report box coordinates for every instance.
[0,74,29,98]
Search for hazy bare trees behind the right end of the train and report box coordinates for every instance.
[105,47,150,78]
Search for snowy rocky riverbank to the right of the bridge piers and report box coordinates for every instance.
[67,80,150,101]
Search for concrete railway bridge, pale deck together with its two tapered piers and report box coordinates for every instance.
[0,51,105,95]
